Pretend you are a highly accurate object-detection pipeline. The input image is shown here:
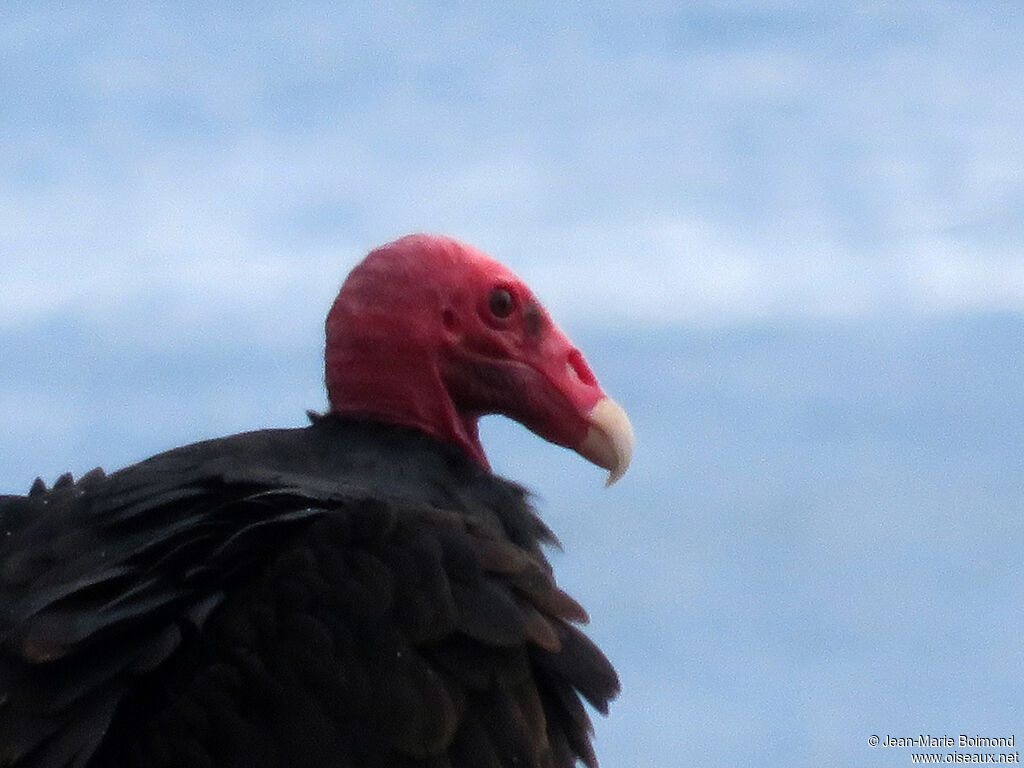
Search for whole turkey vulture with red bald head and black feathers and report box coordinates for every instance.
[0,234,633,768]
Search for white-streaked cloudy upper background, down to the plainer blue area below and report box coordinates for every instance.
[0,3,1024,339]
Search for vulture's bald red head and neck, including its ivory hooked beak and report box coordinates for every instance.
[326,234,632,477]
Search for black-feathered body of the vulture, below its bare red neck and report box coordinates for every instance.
[0,416,618,768]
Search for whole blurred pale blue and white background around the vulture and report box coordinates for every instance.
[0,0,1024,766]
